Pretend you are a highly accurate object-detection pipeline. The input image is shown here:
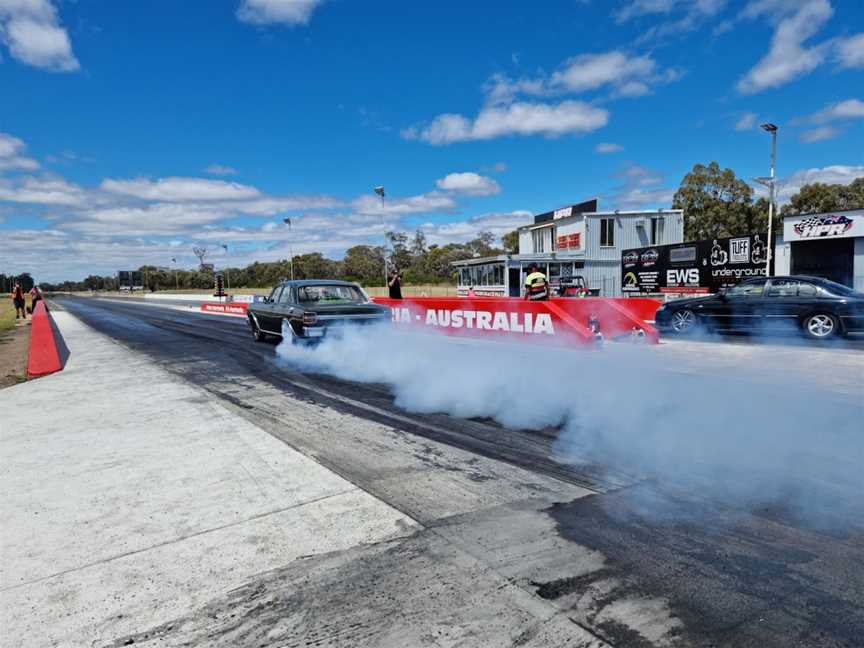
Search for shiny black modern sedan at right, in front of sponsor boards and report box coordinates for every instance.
[654,276,864,340]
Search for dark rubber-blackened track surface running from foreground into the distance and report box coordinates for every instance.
[55,298,864,648]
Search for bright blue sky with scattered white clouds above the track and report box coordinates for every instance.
[0,0,864,281]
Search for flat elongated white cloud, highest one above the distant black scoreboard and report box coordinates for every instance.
[100,178,261,202]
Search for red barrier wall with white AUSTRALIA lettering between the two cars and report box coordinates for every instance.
[373,297,658,344]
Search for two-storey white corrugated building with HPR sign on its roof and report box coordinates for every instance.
[453,200,684,297]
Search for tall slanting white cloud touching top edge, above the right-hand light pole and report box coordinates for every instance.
[737,0,834,94]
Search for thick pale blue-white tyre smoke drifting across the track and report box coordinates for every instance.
[278,325,864,523]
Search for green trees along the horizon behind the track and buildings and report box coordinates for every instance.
[35,162,864,291]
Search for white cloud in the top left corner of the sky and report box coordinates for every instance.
[0,0,80,72]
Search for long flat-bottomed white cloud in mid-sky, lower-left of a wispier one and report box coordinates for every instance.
[403,101,609,144]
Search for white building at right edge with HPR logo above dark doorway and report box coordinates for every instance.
[774,209,864,292]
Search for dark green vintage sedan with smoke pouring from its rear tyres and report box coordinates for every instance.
[246,280,390,341]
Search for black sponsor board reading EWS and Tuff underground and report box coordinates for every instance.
[621,234,768,295]
